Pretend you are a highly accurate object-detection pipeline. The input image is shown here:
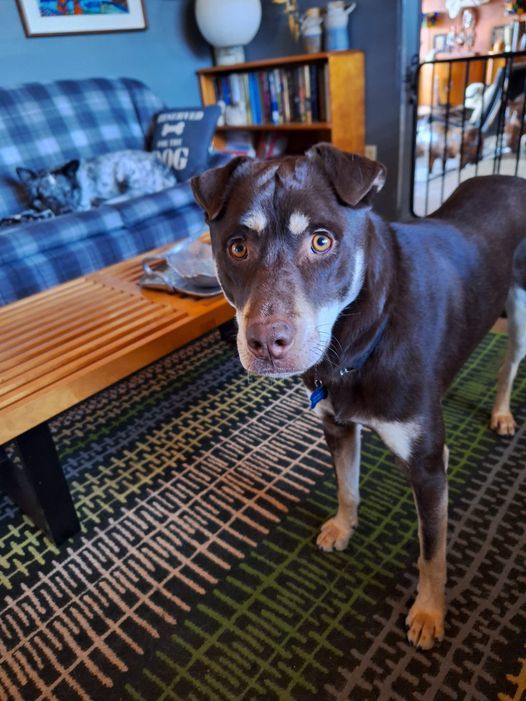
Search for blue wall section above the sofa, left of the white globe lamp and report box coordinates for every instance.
[0,0,211,107]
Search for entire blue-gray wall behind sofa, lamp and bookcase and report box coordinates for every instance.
[0,0,410,216]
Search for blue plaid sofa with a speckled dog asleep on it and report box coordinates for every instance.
[0,78,221,305]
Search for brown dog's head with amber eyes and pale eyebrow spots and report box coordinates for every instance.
[192,144,385,375]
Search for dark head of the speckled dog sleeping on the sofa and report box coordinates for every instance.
[16,160,80,214]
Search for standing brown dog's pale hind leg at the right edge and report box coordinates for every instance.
[490,282,526,436]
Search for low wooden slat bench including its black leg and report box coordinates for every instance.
[0,251,234,543]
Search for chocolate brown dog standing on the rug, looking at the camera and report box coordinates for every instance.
[192,144,526,648]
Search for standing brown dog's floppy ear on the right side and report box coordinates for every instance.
[306,143,387,207]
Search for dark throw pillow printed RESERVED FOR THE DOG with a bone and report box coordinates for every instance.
[151,105,221,182]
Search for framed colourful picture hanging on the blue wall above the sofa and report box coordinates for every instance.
[17,0,148,37]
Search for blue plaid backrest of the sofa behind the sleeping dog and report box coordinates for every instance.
[0,78,163,217]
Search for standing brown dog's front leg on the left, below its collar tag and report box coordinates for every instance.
[317,416,362,552]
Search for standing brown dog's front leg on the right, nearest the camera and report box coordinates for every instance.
[406,446,448,650]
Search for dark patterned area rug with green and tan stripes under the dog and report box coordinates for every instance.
[0,333,526,701]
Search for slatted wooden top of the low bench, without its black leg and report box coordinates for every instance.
[0,243,234,445]
